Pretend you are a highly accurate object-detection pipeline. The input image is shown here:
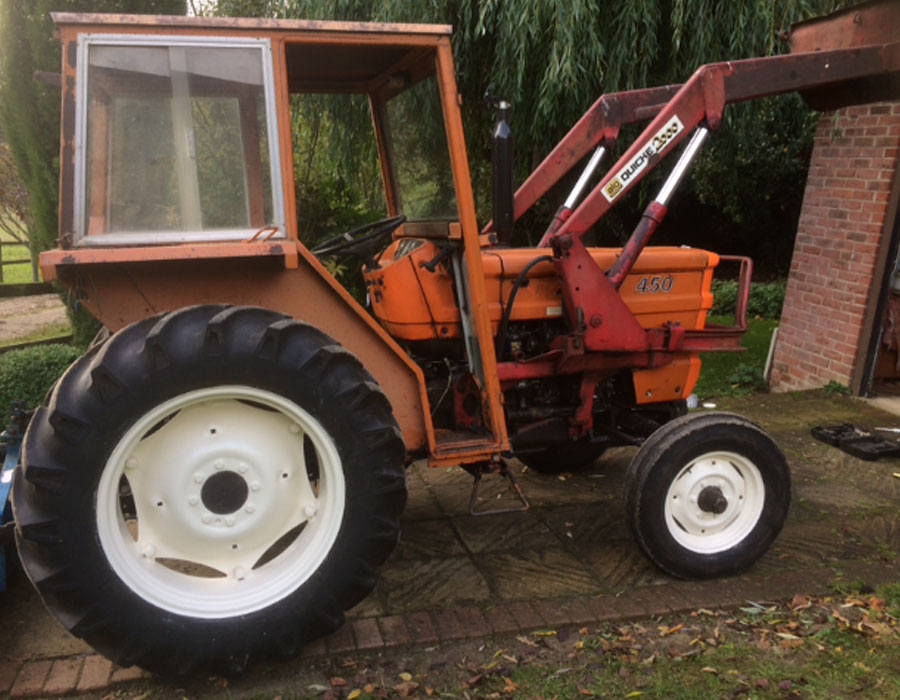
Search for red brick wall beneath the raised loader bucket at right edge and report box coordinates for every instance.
[771,102,900,391]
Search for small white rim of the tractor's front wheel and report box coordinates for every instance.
[665,452,765,554]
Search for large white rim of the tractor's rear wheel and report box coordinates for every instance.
[97,386,345,618]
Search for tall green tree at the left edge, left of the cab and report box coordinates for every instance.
[0,0,185,340]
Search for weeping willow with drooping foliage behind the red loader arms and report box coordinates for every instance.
[218,0,849,274]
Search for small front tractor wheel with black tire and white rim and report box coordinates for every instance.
[625,413,791,578]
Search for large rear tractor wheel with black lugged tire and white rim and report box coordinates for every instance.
[13,306,406,675]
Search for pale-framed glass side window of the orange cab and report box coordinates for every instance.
[75,34,285,246]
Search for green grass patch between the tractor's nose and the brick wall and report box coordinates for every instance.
[694,316,778,399]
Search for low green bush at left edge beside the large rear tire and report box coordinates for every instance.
[0,344,79,422]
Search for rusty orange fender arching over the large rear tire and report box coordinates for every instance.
[54,243,434,453]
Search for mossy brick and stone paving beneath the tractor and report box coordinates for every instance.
[0,399,900,698]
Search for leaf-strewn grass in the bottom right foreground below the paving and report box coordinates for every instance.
[268,583,900,700]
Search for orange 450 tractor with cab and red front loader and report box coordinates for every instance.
[13,3,900,673]
